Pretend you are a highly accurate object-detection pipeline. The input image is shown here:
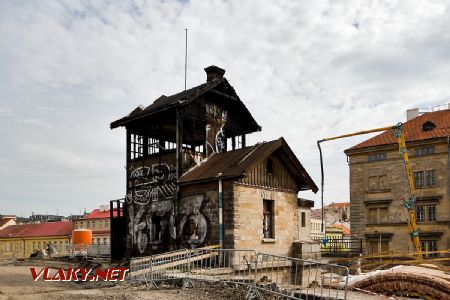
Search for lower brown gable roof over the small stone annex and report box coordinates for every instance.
[180,137,318,192]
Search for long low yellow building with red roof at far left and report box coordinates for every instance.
[0,222,73,258]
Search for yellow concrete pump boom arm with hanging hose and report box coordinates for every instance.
[317,123,423,261]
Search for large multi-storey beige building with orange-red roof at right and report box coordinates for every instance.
[345,110,450,253]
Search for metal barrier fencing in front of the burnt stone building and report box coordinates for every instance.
[129,249,349,299]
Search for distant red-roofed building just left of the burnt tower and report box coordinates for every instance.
[73,205,117,244]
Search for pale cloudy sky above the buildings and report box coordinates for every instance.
[0,0,450,217]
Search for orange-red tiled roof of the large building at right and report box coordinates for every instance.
[344,109,450,153]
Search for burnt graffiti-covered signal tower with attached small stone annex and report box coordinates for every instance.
[111,66,317,258]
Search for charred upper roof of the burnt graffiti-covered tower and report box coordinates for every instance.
[110,78,261,131]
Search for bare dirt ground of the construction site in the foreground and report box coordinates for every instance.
[0,263,386,300]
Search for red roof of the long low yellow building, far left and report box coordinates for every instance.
[0,222,73,238]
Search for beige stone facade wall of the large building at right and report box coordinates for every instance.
[349,139,450,251]
